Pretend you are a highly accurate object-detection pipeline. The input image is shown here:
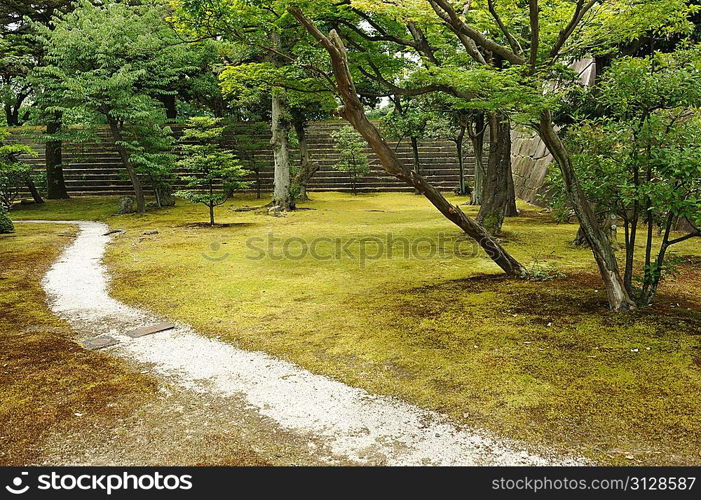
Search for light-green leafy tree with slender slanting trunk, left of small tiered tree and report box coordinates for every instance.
[34,0,191,212]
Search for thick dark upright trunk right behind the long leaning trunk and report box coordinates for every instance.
[477,113,511,234]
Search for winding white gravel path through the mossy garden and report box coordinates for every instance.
[21,221,583,465]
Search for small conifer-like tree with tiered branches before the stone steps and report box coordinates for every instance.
[175,116,248,226]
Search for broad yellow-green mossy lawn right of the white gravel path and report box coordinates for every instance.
[12,193,701,464]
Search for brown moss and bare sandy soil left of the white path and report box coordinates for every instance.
[0,224,267,466]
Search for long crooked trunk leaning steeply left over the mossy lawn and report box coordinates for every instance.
[288,12,525,276]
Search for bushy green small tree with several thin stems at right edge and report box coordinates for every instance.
[551,51,701,306]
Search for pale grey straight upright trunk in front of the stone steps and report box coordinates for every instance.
[270,96,290,210]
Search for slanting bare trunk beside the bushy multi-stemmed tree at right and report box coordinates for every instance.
[538,111,635,311]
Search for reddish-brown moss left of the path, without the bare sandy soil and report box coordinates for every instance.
[0,224,155,465]
